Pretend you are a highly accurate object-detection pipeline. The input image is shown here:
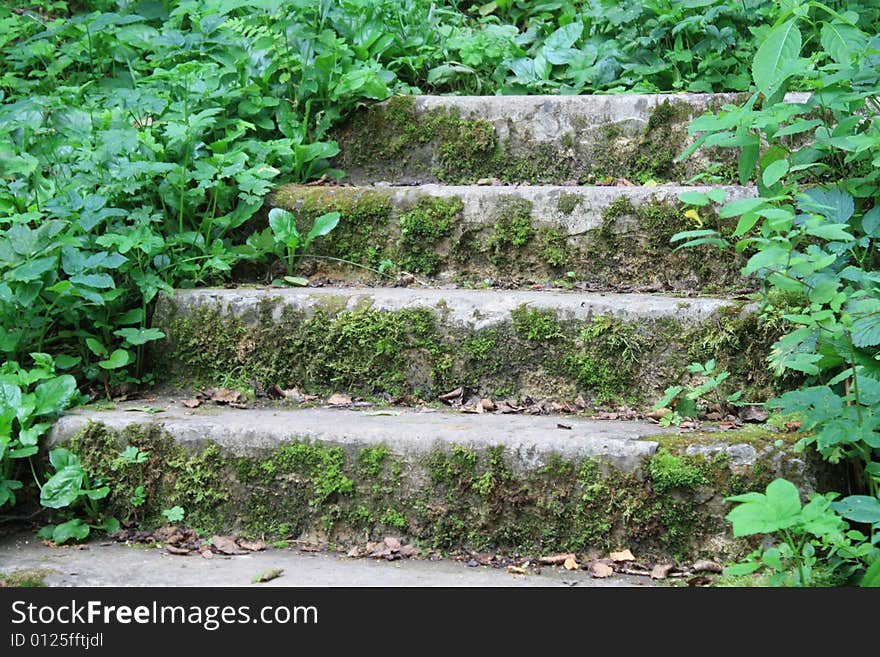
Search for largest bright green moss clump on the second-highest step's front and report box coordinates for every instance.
[397,196,462,275]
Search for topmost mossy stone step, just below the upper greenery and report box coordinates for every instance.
[334,94,808,184]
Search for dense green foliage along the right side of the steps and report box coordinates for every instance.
[674,2,880,584]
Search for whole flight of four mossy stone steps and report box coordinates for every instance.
[51,95,815,556]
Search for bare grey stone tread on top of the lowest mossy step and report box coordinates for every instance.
[49,398,676,470]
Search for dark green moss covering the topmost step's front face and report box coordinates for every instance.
[334,96,736,184]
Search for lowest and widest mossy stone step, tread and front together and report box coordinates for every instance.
[49,399,809,556]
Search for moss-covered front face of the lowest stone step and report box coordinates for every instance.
[62,423,804,558]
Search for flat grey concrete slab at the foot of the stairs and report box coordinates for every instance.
[0,533,663,588]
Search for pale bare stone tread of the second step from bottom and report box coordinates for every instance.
[165,286,734,329]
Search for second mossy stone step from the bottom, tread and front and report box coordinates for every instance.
[152,287,774,403]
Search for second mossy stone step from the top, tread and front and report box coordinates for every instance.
[272,185,755,291]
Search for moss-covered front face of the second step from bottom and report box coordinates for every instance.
[151,295,784,404]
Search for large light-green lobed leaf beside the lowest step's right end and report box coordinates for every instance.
[726,479,801,537]
